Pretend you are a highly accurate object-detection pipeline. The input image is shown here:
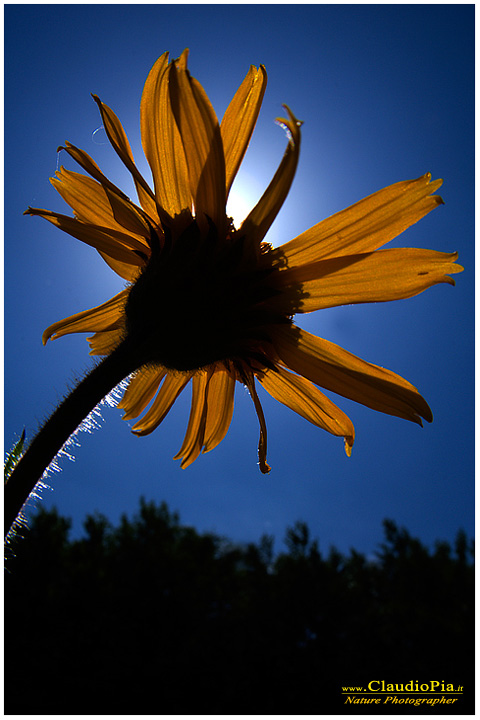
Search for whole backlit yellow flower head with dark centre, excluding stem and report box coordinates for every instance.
[27,51,462,472]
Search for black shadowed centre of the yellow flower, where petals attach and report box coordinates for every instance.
[125,221,290,370]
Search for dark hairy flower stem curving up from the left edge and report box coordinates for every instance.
[4,338,141,535]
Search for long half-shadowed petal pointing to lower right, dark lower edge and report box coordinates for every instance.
[272,326,433,425]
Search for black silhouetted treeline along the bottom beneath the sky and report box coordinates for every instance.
[5,499,474,715]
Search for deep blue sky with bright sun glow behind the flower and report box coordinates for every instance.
[5,5,474,552]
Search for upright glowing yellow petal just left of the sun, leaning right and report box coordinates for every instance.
[220,65,267,197]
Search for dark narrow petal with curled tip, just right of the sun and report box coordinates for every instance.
[240,105,302,246]
